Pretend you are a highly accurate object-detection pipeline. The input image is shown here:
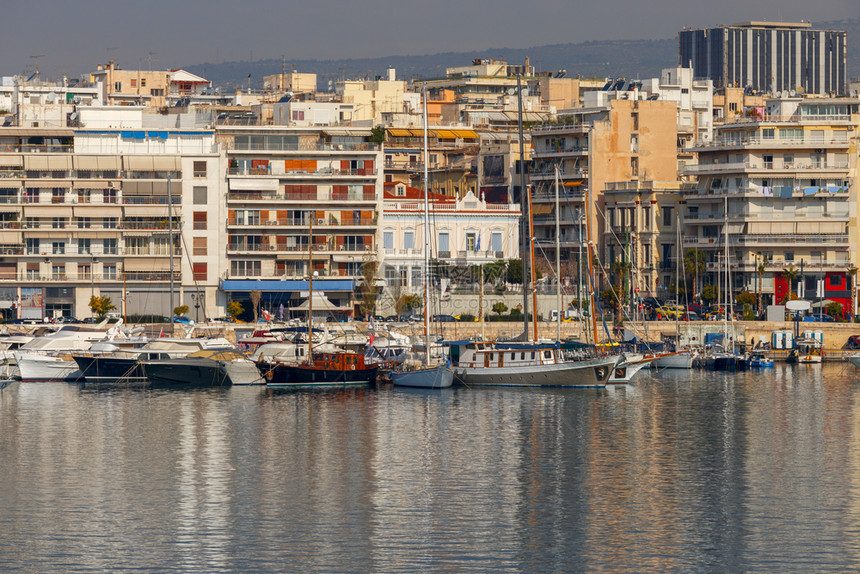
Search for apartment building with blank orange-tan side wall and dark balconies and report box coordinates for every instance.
[530,90,678,288]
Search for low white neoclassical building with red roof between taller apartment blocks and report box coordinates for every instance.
[380,182,521,299]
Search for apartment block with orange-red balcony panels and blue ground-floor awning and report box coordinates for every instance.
[216,126,382,316]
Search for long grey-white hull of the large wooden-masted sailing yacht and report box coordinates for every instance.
[454,357,618,388]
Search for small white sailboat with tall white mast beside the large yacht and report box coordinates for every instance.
[391,88,454,389]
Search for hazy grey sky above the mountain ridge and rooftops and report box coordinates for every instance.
[0,0,860,79]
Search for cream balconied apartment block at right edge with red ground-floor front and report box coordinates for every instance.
[684,98,860,310]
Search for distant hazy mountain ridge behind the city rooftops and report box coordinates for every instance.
[185,18,860,90]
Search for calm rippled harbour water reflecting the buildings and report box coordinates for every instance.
[0,362,860,573]
